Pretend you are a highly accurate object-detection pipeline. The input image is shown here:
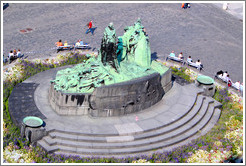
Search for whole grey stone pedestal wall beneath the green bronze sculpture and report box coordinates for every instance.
[49,70,172,117]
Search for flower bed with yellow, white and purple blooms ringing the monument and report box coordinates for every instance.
[3,56,243,163]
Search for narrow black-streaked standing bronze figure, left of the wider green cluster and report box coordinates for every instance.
[100,23,119,70]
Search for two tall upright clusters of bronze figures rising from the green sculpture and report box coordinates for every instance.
[98,19,151,71]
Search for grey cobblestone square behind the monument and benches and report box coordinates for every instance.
[3,3,243,81]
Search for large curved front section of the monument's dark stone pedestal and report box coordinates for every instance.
[90,73,164,116]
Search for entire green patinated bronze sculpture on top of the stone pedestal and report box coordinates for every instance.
[51,19,168,93]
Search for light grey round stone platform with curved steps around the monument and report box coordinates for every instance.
[10,66,220,157]
